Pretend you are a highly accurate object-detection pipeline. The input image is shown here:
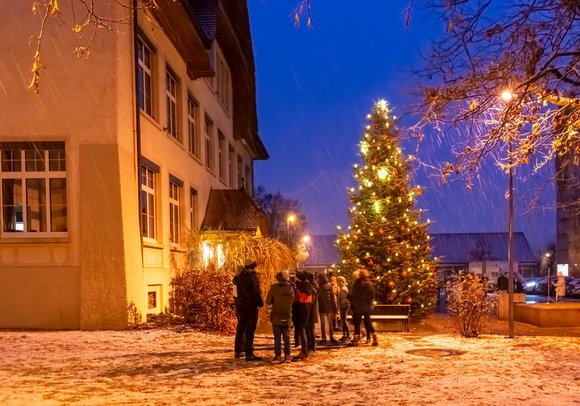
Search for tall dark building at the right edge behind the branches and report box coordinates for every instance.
[556,151,580,276]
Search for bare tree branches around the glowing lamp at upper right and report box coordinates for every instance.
[415,0,580,190]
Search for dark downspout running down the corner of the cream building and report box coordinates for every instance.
[133,0,143,256]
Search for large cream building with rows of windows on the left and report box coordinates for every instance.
[0,0,268,329]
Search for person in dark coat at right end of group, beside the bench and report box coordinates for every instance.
[350,269,379,345]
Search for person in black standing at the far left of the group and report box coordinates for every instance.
[234,260,264,361]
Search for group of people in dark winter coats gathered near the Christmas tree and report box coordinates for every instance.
[233,260,378,362]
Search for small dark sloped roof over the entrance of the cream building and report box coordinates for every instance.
[201,189,268,234]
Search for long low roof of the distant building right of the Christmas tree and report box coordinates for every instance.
[431,232,538,264]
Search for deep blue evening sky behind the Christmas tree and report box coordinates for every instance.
[248,0,555,253]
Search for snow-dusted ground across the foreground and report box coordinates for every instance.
[0,316,580,405]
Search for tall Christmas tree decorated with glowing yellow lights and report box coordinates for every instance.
[338,100,437,315]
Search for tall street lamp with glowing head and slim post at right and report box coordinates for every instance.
[500,89,514,338]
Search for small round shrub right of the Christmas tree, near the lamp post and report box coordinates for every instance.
[447,273,494,337]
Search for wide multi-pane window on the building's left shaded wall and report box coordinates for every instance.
[0,142,68,236]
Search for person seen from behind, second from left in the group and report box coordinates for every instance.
[266,271,294,362]
